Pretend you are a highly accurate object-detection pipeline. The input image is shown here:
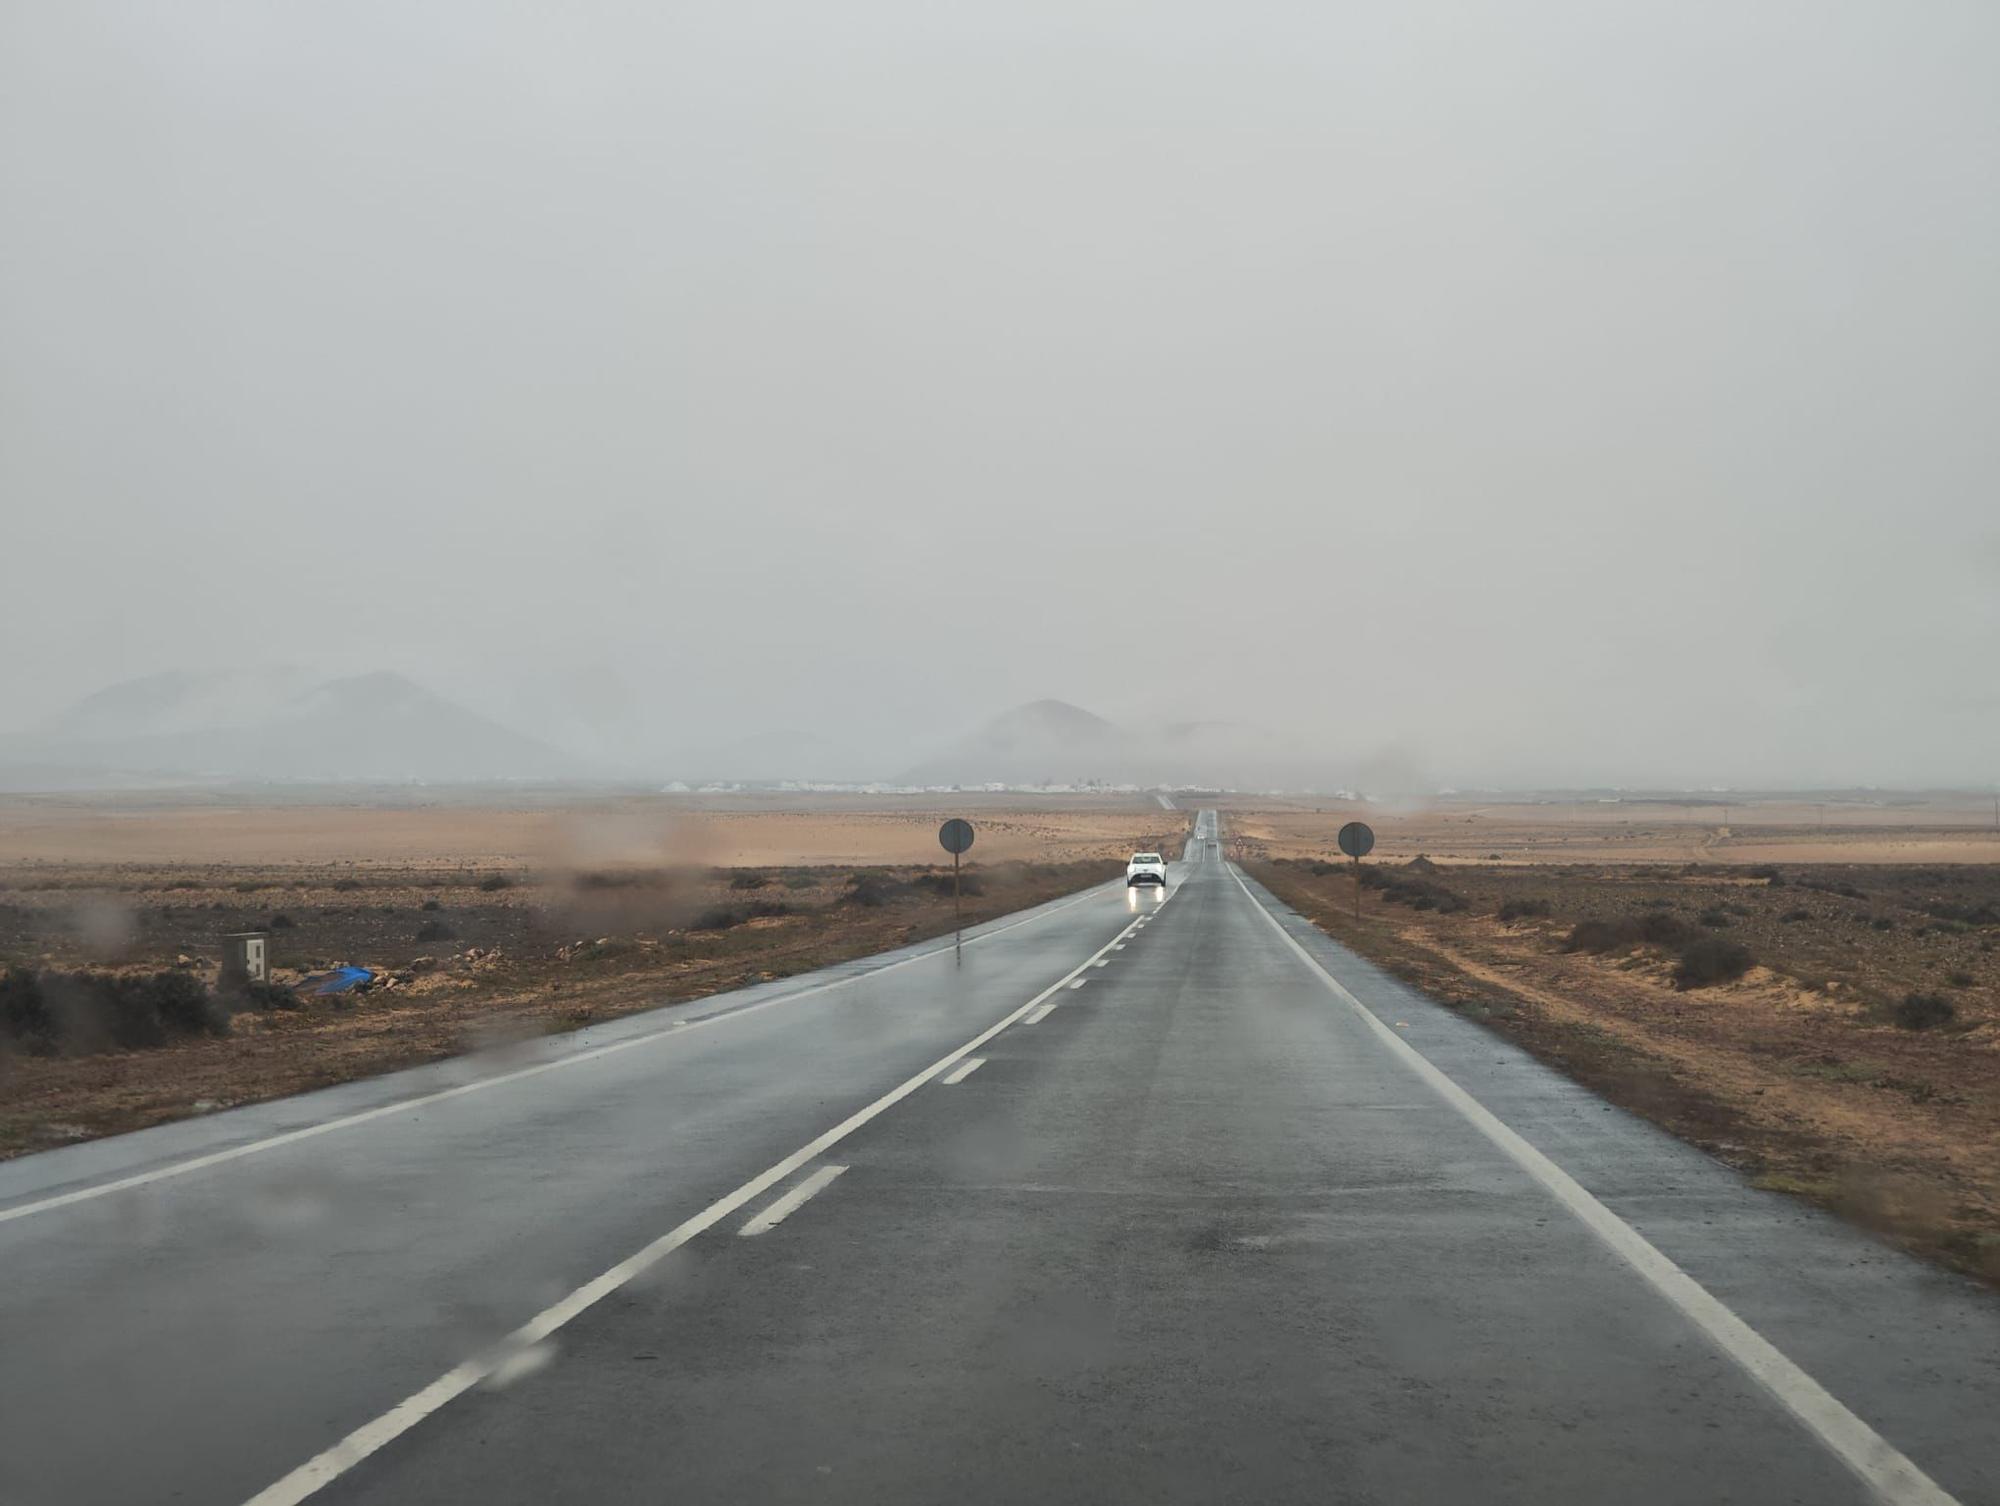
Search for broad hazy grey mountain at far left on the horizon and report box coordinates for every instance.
[0,668,584,788]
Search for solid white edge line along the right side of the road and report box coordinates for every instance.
[1230,868,1958,1506]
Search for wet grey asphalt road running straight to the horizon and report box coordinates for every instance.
[0,812,2000,1506]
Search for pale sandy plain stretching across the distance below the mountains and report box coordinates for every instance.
[0,790,2000,868]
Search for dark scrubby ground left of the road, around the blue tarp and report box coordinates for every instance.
[0,862,1116,1154]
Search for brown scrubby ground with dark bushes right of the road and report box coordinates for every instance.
[1240,844,2000,1282]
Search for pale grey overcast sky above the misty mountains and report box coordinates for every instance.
[0,0,2000,782]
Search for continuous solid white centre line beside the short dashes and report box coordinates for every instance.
[246,904,1124,1506]
